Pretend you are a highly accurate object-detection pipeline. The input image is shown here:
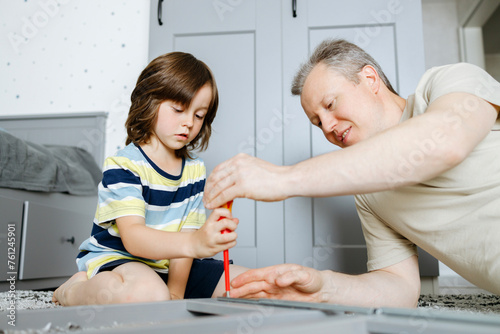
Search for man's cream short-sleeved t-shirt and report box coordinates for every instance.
[356,63,500,294]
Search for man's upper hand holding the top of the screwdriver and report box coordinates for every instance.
[203,153,290,209]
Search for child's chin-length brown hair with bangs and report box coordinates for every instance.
[125,52,219,158]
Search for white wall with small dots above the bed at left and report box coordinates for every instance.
[0,0,149,159]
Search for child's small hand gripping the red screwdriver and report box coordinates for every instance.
[192,208,239,258]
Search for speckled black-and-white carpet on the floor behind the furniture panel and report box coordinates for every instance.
[0,290,500,315]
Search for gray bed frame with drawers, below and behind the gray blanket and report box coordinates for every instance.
[0,112,107,291]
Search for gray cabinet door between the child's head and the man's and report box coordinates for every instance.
[149,0,284,268]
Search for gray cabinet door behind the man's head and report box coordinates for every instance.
[282,0,424,273]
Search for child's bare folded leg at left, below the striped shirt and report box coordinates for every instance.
[52,262,170,306]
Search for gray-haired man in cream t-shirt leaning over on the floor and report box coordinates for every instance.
[205,40,500,307]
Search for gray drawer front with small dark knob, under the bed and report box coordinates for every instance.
[19,196,96,280]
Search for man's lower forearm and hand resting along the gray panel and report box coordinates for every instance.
[231,255,420,307]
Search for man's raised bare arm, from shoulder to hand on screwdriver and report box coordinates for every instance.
[204,93,498,208]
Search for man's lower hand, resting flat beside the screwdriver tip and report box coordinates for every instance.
[231,264,328,302]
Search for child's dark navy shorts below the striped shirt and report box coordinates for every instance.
[99,258,233,299]
